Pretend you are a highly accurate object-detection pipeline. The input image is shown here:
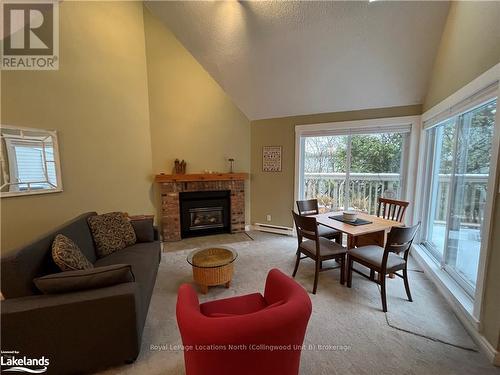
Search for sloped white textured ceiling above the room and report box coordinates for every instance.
[147,1,449,120]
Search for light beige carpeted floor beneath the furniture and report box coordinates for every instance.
[99,232,500,375]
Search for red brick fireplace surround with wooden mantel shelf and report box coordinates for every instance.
[155,173,248,241]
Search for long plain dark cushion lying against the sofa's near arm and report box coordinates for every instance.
[33,264,135,294]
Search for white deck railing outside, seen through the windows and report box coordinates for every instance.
[304,172,488,225]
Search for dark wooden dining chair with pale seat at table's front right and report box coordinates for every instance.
[347,223,420,312]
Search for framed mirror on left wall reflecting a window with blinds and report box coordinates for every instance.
[0,126,62,197]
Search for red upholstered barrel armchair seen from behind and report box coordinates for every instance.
[177,269,311,375]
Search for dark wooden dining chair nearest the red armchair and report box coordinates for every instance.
[292,211,347,294]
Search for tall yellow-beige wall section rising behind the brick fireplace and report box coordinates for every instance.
[144,8,250,221]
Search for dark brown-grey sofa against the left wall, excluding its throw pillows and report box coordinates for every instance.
[1,212,161,374]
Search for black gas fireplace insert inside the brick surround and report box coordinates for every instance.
[179,190,231,238]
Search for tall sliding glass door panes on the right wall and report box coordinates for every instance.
[423,99,497,296]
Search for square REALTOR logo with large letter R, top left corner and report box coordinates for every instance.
[1,0,59,70]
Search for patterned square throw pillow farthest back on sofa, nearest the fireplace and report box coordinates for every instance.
[88,212,136,258]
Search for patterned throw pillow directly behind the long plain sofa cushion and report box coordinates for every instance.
[52,234,94,271]
